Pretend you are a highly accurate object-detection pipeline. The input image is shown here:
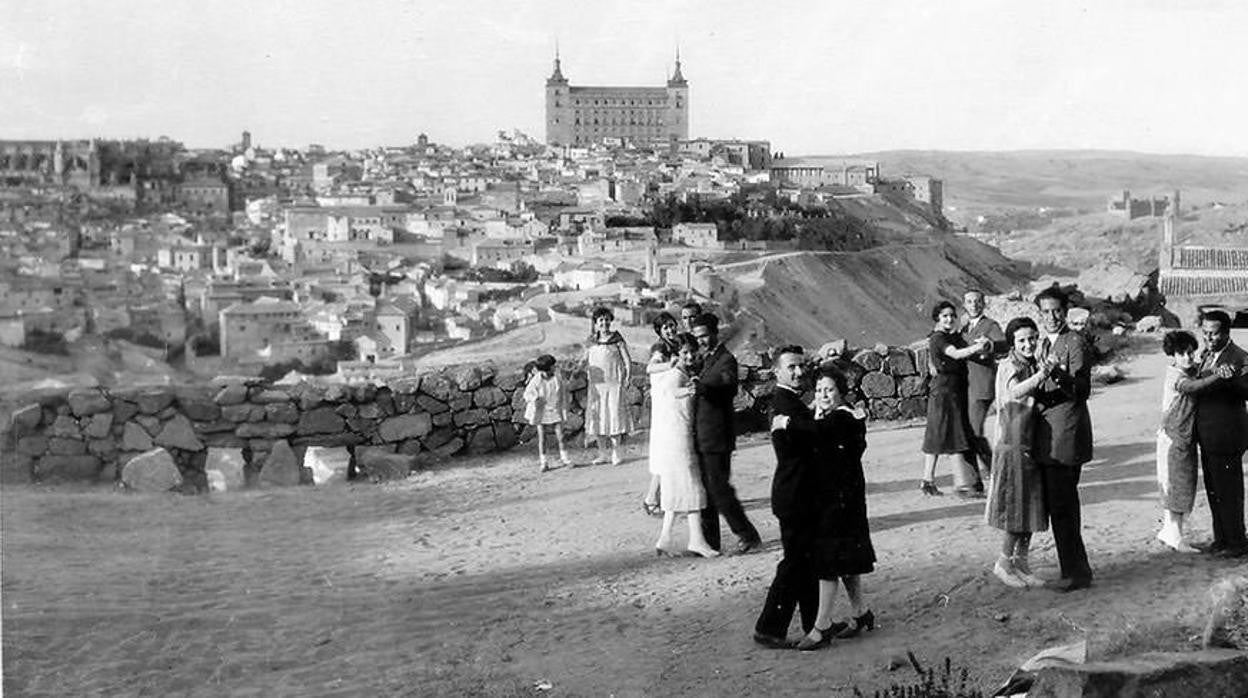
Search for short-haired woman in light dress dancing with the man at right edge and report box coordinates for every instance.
[1157,330,1219,553]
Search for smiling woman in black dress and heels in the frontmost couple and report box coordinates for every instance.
[797,367,875,649]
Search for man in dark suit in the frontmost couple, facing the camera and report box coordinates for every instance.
[754,346,819,648]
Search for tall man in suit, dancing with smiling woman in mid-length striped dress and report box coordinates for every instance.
[1032,287,1092,592]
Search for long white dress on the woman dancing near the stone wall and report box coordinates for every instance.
[650,368,706,512]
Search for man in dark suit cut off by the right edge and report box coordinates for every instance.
[1196,310,1248,557]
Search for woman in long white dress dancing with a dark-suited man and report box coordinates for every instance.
[650,336,719,557]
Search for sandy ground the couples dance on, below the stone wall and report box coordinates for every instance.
[0,344,1243,696]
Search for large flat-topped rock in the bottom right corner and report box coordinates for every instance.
[1027,649,1248,698]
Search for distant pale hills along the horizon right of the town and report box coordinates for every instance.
[805,150,1248,221]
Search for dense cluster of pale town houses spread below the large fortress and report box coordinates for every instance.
[0,132,943,382]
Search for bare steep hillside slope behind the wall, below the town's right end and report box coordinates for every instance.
[724,237,1027,347]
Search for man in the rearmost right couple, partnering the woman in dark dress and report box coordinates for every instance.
[958,288,1008,497]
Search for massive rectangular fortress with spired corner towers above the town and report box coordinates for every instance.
[547,51,689,146]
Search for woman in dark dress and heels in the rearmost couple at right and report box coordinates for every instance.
[919,301,992,496]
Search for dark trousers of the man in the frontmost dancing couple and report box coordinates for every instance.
[754,517,819,638]
